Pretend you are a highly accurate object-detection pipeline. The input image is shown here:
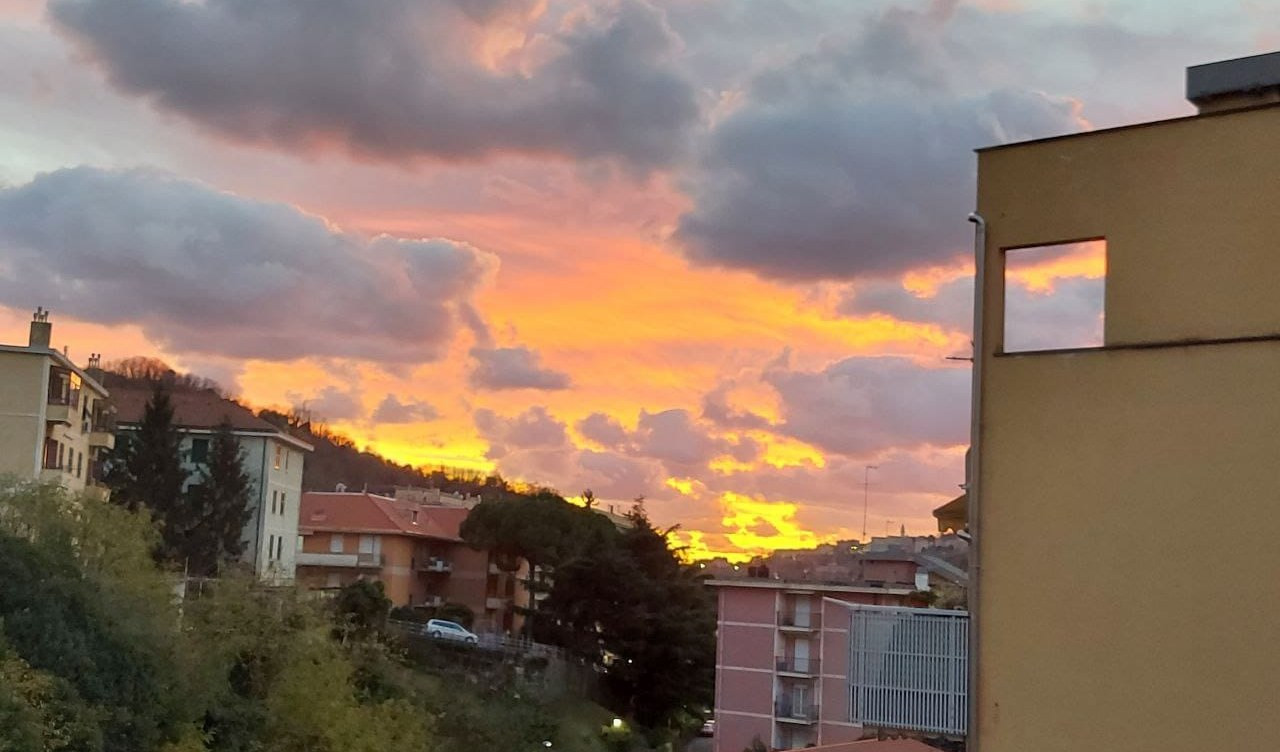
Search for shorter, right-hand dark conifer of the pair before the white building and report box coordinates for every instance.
[183,419,253,576]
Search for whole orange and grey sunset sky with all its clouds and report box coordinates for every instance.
[0,0,1280,555]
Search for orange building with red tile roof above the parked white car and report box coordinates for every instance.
[298,491,529,633]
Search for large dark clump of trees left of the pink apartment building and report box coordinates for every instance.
[462,492,716,728]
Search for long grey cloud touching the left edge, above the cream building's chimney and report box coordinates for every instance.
[0,168,497,363]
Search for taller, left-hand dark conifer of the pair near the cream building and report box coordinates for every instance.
[105,381,187,559]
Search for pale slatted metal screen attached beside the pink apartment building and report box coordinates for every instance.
[849,606,969,737]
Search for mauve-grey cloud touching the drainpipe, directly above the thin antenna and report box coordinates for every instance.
[764,357,970,455]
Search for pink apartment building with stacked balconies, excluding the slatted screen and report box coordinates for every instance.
[709,579,915,752]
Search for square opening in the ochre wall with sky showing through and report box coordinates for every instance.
[1004,240,1107,353]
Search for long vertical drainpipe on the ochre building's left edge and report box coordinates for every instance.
[965,212,987,752]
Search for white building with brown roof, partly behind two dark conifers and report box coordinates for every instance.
[111,386,312,583]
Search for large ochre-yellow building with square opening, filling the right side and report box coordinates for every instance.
[969,54,1280,752]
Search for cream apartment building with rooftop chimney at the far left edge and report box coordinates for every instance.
[0,311,115,491]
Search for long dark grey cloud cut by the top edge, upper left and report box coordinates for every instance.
[50,0,699,168]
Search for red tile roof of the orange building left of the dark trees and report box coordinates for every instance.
[298,491,467,542]
